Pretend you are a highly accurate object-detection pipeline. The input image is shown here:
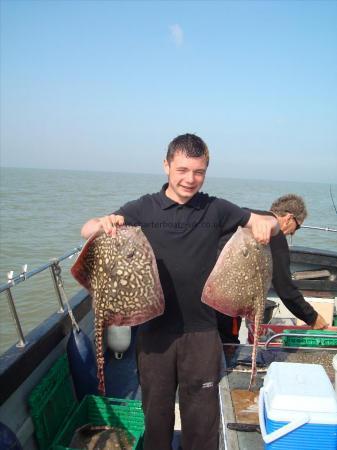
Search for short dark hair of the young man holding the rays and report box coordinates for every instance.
[166,133,209,165]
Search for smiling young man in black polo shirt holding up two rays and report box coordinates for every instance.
[82,134,279,450]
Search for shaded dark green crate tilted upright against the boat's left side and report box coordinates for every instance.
[28,354,78,450]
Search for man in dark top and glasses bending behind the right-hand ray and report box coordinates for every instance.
[217,194,328,343]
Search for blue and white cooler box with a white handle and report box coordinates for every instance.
[259,362,337,450]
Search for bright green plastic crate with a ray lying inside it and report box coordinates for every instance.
[52,395,144,450]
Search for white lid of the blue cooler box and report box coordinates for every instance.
[263,362,337,414]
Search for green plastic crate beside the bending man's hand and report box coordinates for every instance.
[282,330,337,347]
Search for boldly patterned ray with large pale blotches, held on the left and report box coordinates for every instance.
[71,226,165,394]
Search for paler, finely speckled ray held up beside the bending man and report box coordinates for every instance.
[202,227,273,390]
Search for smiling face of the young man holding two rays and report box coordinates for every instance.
[164,151,207,204]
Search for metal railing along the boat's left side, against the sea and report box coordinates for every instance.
[0,246,82,347]
